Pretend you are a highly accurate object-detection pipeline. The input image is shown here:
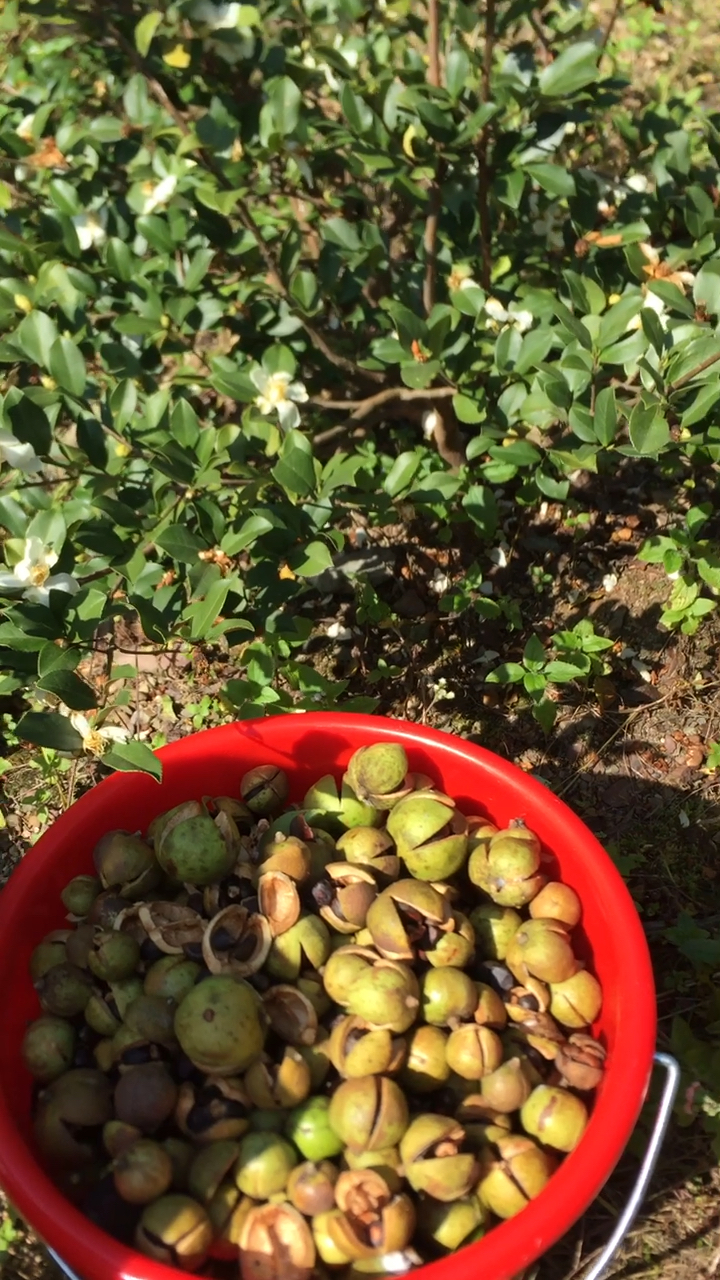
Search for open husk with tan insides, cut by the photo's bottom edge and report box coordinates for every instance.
[240,1203,315,1280]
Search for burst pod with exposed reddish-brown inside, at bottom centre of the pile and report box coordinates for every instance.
[328,1169,415,1261]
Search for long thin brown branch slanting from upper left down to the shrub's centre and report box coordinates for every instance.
[104,18,384,383]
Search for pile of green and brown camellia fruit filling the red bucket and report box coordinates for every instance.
[23,742,605,1280]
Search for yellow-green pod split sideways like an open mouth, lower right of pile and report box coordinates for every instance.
[400,1114,478,1201]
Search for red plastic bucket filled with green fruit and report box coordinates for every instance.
[0,713,656,1280]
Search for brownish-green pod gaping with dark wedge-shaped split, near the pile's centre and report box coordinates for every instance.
[366,879,452,961]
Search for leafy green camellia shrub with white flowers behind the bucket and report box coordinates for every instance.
[0,0,720,771]
